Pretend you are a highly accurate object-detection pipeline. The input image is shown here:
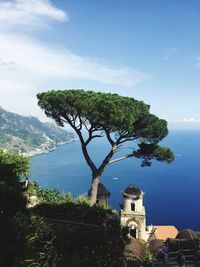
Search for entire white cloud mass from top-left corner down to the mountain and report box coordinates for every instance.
[0,0,152,118]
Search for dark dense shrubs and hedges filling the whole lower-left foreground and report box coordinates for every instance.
[0,151,156,267]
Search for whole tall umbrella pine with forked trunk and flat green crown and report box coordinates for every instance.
[37,90,174,205]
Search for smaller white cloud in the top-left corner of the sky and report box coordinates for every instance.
[0,0,68,29]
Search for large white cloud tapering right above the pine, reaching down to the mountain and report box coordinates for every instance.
[0,32,150,116]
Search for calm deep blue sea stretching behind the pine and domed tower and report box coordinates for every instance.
[31,130,200,231]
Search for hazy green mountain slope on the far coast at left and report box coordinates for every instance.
[0,107,75,154]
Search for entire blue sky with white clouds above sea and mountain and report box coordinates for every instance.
[0,0,200,128]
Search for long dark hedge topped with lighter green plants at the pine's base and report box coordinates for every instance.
[27,182,117,225]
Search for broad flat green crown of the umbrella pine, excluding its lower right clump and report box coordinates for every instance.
[37,90,168,142]
